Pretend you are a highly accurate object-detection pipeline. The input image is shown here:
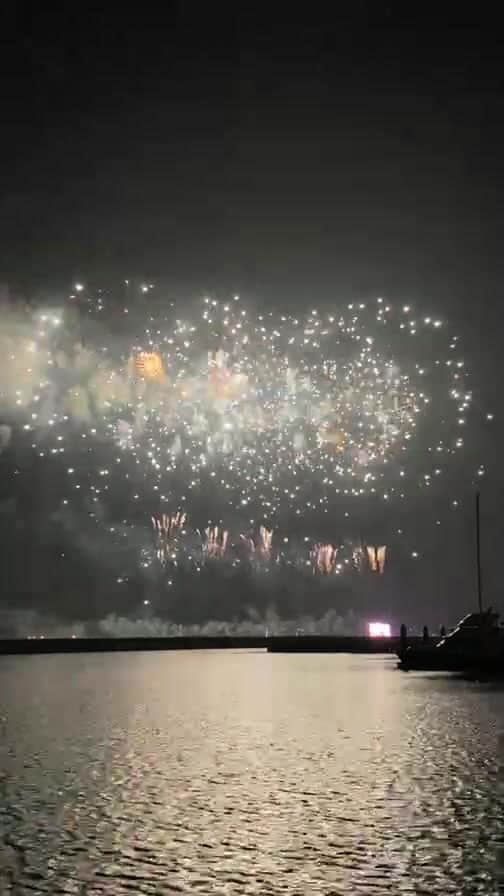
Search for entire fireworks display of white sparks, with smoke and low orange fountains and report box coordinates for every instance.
[0,285,488,575]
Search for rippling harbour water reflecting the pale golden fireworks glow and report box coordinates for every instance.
[0,652,504,896]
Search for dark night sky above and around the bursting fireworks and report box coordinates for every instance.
[0,3,504,636]
